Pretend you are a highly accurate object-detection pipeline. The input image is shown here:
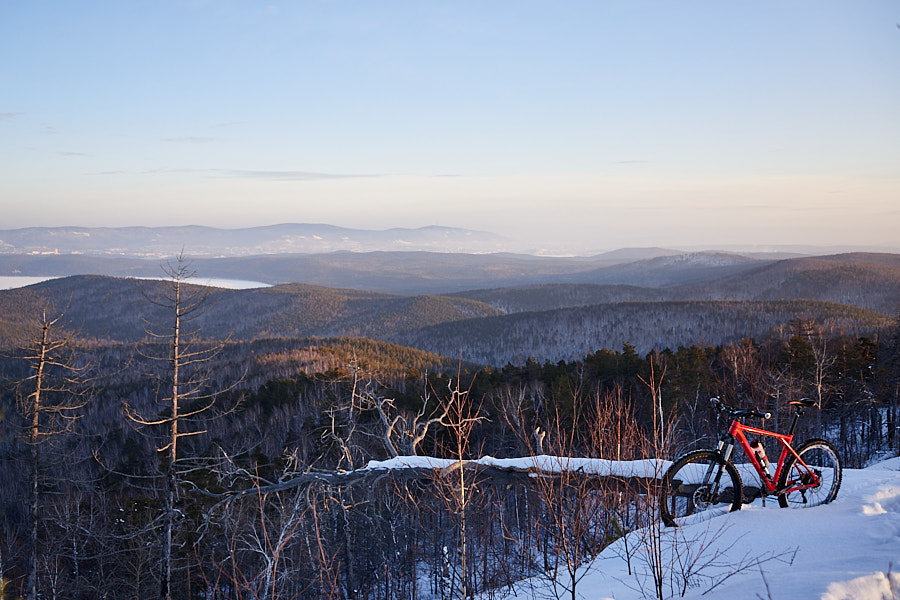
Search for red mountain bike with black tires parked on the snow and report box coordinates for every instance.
[659,398,841,527]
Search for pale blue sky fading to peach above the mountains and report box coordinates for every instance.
[0,0,900,250]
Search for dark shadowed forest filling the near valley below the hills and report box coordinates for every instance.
[0,307,900,599]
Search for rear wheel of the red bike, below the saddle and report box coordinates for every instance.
[778,439,843,508]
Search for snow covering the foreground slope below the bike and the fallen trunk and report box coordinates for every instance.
[368,456,900,600]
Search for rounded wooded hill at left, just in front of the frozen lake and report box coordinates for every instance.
[0,276,501,346]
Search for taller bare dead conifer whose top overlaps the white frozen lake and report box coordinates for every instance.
[124,250,236,600]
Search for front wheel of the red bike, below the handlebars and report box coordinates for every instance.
[659,450,744,527]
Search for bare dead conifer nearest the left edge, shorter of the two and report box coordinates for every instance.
[17,311,88,599]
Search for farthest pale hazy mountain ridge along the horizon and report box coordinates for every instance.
[0,223,900,263]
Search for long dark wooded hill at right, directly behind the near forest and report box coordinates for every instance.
[400,300,891,365]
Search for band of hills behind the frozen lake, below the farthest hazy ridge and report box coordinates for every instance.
[0,252,900,315]
